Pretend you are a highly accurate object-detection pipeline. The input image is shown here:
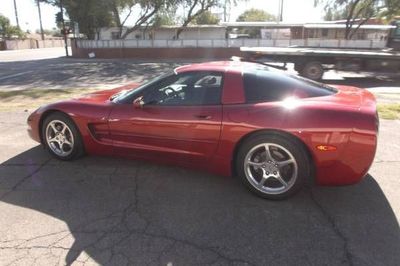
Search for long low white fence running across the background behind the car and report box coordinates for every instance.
[77,39,386,49]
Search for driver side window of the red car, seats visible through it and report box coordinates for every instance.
[143,71,223,105]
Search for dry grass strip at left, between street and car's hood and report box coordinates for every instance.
[0,88,96,112]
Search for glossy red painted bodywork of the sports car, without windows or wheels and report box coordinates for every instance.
[28,62,377,185]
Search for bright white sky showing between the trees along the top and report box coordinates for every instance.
[0,0,323,32]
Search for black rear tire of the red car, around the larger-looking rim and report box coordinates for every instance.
[235,134,311,200]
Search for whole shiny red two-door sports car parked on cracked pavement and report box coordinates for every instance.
[28,61,379,199]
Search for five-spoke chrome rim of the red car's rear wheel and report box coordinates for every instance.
[244,143,298,194]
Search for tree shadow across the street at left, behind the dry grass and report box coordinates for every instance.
[0,58,178,89]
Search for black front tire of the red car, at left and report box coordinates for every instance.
[41,112,84,161]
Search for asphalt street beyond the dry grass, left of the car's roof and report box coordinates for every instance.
[0,48,184,91]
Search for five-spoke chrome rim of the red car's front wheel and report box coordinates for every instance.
[46,120,74,157]
